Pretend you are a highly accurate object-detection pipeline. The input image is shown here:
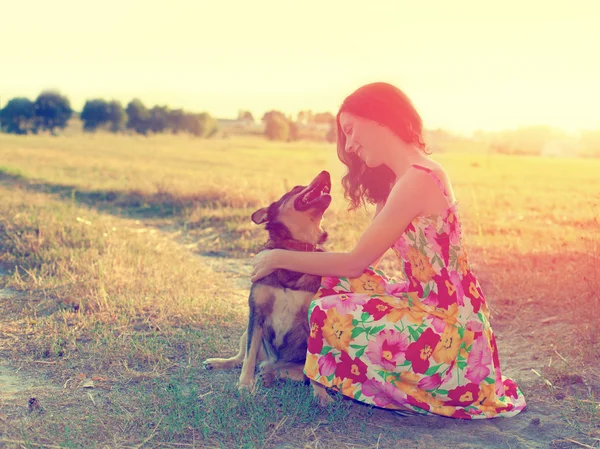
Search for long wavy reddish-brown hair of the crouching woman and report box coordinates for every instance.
[336,82,429,211]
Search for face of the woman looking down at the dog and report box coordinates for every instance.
[340,112,384,168]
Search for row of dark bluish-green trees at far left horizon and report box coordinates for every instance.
[0,91,218,137]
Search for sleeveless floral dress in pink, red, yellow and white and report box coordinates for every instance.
[304,166,526,419]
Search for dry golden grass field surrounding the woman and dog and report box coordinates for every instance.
[0,134,600,449]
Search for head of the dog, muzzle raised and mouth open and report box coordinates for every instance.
[252,171,331,246]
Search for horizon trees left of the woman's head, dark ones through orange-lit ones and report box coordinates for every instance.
[0,91,337,142]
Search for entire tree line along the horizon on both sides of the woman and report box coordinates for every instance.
[0,91,600,157]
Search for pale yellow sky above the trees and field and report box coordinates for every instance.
[0,0,600,133]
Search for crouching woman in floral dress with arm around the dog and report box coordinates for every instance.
[252,83,525,419]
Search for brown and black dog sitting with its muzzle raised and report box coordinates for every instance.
[204,171,332,406]
